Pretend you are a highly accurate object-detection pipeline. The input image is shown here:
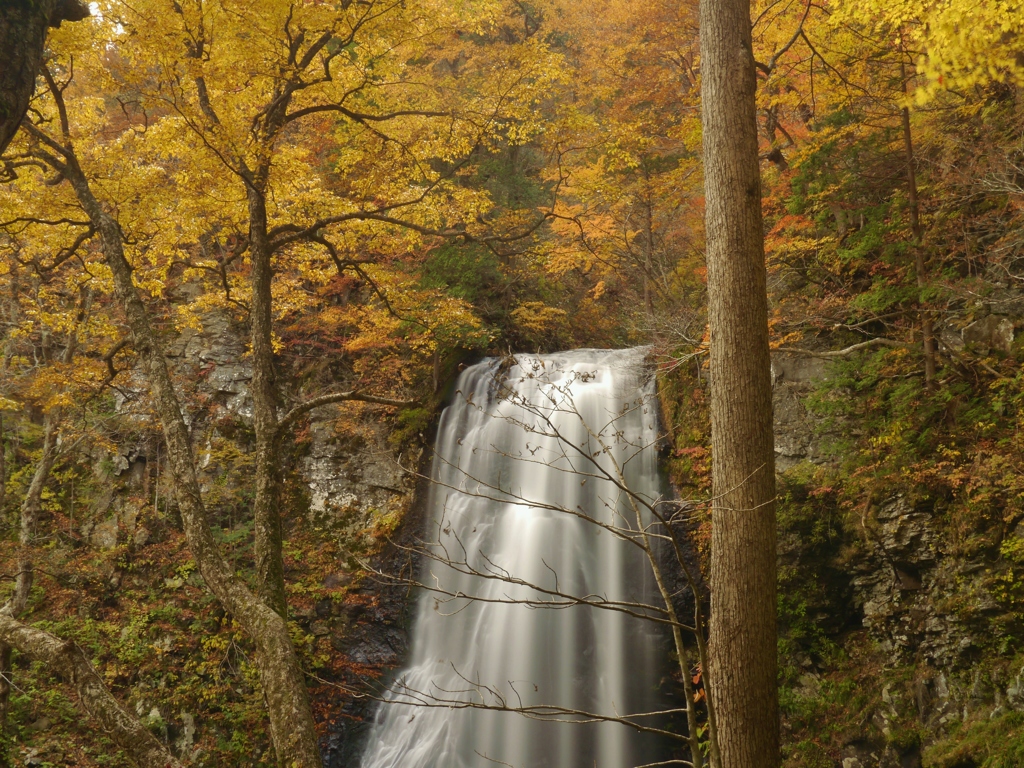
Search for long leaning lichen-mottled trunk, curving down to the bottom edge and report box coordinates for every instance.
[59,156,322,768]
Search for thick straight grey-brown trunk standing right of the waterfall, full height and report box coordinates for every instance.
[700,0,779,768]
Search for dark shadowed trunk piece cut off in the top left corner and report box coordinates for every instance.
[0,0,89,153]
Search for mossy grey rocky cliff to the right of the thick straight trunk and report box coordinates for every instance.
[773,314,1024,768]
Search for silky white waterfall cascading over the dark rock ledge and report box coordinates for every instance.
[361,349,671,768]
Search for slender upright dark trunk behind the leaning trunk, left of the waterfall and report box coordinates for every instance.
[247,189,288,616]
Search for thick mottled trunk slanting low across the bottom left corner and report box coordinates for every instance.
[0,607,181,768]
